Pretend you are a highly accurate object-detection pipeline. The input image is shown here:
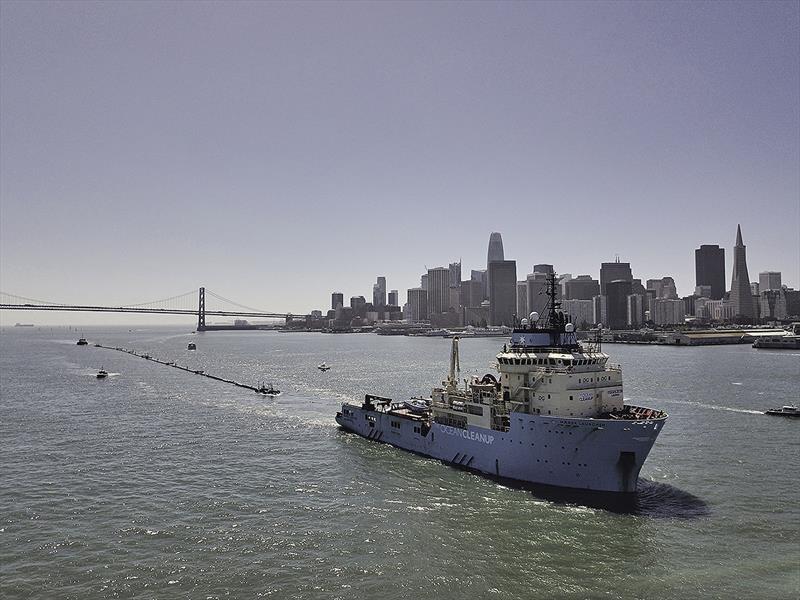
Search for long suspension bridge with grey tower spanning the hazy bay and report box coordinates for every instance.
[0,287,309,331]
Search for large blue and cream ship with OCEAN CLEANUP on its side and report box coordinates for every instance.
[336,275,667,494]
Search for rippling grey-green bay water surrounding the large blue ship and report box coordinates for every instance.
[0,327,800,600]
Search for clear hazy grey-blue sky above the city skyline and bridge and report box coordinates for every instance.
[0,1,800,324]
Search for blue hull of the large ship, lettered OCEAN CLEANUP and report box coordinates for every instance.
[336,403,666,493]
